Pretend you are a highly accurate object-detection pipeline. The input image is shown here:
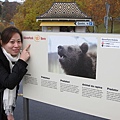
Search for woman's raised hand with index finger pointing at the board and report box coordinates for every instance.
[20,44,30,62]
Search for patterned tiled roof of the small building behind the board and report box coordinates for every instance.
[36,2,90,19]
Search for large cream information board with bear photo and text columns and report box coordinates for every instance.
[22,31,120,120]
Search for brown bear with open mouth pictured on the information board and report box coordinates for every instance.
[58,43,97,79]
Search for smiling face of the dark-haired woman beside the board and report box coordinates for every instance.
[2,33,22,57]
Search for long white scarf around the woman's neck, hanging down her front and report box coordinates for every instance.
[2,47,20,115]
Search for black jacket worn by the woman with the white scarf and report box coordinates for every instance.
[0,47,28,120]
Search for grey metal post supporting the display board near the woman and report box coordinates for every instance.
[23,97,29,120]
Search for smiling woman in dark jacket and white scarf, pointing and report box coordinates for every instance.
[0,26,30,120]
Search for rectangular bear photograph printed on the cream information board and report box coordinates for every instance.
[48,36,97,79]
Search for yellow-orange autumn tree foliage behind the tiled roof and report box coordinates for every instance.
[0,0,120,30]
